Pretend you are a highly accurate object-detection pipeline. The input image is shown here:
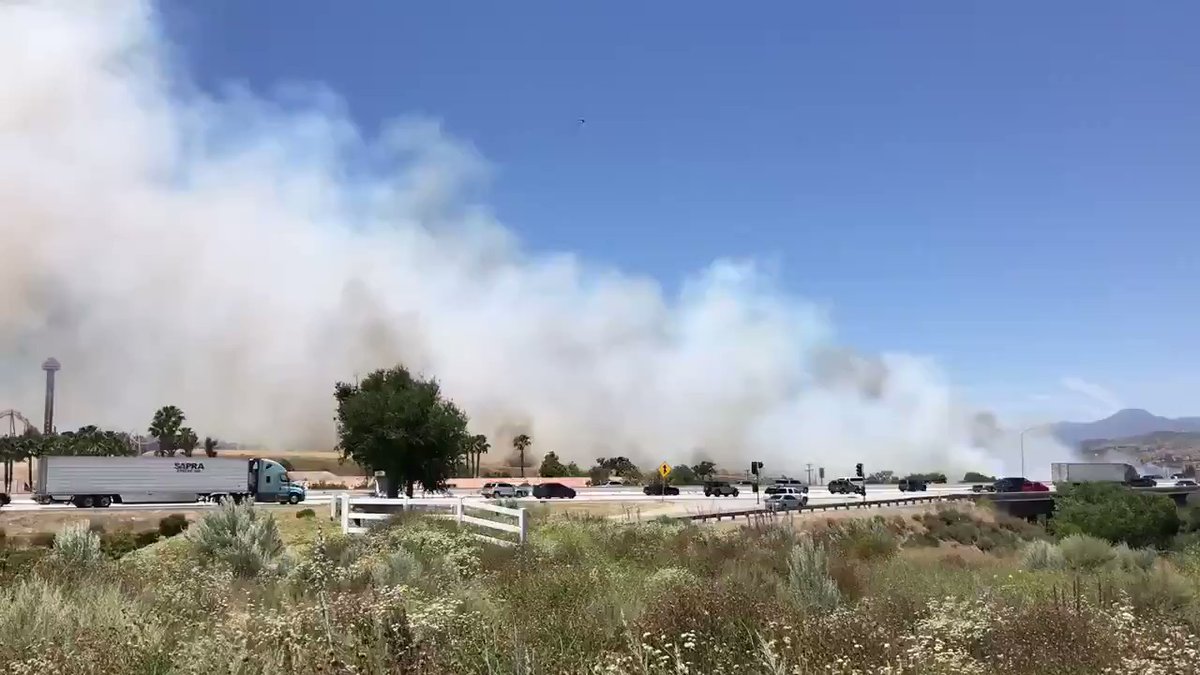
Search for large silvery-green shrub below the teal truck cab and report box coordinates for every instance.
[186,502,283,577]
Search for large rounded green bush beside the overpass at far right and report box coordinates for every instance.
[1050,483,1181,548]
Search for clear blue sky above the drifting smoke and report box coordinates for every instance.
[164,0,1200,417]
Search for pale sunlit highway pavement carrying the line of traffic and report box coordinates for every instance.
[0,484,971,513]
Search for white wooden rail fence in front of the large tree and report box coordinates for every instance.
[329,492,529,545]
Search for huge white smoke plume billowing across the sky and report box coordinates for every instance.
[0,0,1051,473]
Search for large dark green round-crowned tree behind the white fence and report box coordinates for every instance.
[334,366,467,497]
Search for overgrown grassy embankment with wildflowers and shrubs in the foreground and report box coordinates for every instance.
[0,502,1200,675]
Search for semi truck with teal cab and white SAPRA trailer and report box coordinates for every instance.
[34,455,307,508]
